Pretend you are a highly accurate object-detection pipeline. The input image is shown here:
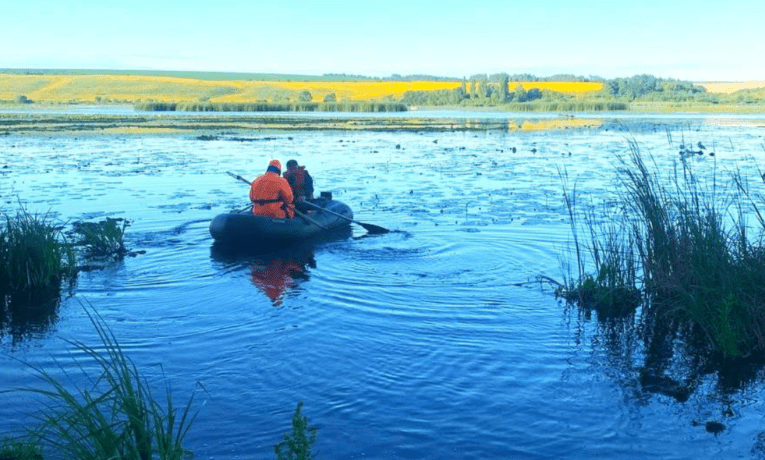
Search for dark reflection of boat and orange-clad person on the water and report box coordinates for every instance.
[210,227,352,307]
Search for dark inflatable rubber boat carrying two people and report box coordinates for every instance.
[210,199,353,246]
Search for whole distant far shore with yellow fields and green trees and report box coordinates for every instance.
[0,71,765,112]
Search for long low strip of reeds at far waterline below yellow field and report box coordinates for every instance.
[134,102,407,112]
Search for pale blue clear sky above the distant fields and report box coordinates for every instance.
[0,0,765,81]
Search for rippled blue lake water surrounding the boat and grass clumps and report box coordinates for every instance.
[0,109,765,460]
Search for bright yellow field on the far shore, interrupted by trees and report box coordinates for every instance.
[0,74,603,104]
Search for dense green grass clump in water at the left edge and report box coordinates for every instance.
[0,208,76,292]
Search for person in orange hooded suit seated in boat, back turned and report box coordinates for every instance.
[250,160,295,219]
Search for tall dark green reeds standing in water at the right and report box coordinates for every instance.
[558,142,765,359]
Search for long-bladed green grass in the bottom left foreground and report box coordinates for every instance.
[27,306,195,460]
